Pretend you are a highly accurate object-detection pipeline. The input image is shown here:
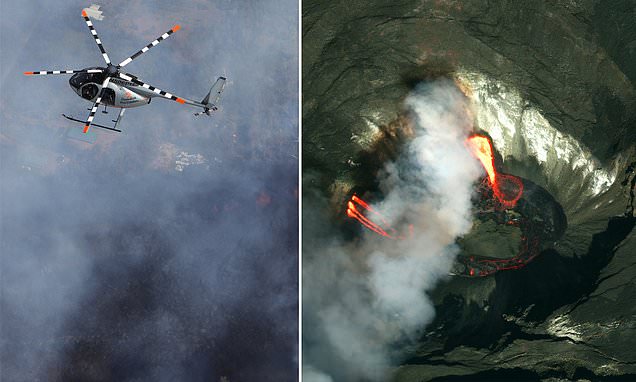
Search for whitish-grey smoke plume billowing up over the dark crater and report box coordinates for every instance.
[303,81,482,382]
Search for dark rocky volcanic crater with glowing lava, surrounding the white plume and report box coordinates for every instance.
[302,0,636,382]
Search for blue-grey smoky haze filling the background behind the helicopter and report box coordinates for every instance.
[0,0,298,381]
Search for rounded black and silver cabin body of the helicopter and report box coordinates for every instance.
[68,67,156,108]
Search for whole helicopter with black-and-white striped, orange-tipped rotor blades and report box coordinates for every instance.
[24,9,227,134]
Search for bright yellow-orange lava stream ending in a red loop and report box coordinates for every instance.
[466,135,523,208]
